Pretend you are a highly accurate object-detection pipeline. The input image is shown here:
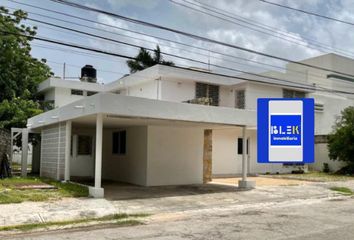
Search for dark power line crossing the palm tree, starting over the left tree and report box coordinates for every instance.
[0,29,354,95]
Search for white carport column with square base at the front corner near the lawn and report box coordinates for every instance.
[89,113,104,198]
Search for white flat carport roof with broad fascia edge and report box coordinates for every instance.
[27,93,256,130]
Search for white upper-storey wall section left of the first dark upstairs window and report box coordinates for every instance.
[161,80,195,102]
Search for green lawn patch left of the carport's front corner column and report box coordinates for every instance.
[0,177,88,204]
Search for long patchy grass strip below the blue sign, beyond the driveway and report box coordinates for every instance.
[266,172,354,182]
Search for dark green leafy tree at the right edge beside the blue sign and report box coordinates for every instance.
[328,106,354,173]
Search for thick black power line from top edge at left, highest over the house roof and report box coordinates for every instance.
[50,0,354,77]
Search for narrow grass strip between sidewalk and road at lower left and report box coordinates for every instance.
[0,213,149,231]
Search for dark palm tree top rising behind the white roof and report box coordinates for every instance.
[127,45,175,73]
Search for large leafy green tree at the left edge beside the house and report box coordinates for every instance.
[0,6,52,128]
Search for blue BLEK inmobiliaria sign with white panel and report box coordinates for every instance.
[257,98,314,163]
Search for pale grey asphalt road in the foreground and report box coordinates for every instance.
[4,194,354,240]
